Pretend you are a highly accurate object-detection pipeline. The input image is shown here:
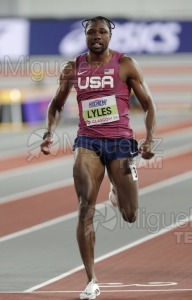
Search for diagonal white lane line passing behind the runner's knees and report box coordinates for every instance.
[0,171,192,243]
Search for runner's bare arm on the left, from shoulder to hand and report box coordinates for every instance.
[41,61,75,155]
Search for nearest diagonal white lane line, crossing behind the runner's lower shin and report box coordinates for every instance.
[23,216,192,293]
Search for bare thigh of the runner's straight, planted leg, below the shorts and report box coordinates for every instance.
[73,147,105,203]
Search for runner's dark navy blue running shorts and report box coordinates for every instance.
[74,135,139,165]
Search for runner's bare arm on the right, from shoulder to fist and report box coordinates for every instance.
[120,57,156,159]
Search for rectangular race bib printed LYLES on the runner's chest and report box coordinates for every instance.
[82,95,119,126]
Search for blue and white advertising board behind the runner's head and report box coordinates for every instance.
[0,19,192,61]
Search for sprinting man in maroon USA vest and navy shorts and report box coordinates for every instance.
[41,16,155,299]
